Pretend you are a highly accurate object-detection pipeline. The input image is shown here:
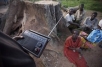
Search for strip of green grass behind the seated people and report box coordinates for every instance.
[60,0,102,12]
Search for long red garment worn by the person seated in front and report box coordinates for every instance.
[64,36,88,67]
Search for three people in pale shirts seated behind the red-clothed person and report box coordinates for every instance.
[65,4,98,34]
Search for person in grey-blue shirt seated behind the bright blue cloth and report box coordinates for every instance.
[81,12,98,34]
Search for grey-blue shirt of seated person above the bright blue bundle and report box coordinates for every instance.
[83,17,98,29]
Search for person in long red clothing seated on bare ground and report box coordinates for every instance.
[64,30,88,67]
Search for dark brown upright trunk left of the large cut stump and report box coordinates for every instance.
[3,0,24,35]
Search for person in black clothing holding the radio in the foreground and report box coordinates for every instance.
[0,31,36,67]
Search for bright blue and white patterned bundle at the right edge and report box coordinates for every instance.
[87,29,102,43]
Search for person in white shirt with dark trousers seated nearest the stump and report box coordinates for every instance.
[65,9,79,31]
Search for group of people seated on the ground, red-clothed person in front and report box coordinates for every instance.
[64,4,102,67]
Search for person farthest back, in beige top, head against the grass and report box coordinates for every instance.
[75,4,85,24]
